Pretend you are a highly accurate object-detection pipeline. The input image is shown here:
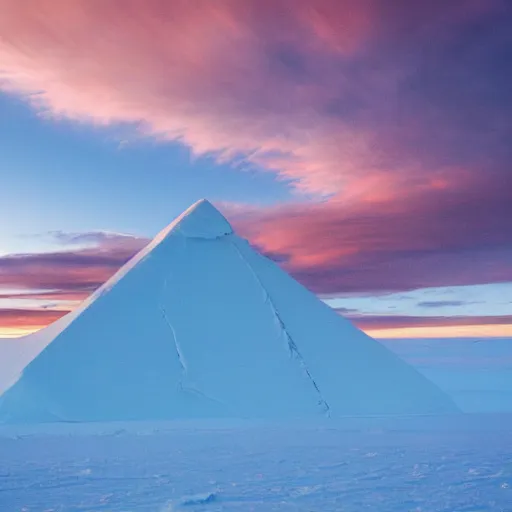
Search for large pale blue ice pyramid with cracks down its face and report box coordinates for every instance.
[0,200,455,422]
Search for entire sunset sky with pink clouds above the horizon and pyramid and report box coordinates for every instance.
[0,0,512,338]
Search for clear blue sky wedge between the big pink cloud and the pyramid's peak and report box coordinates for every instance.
[0,94,291,253]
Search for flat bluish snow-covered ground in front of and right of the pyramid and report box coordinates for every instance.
[0,340,512,512]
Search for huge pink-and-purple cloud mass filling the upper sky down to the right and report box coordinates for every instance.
[0,0,512,300]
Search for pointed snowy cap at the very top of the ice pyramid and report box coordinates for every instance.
[158,199,233,239]
